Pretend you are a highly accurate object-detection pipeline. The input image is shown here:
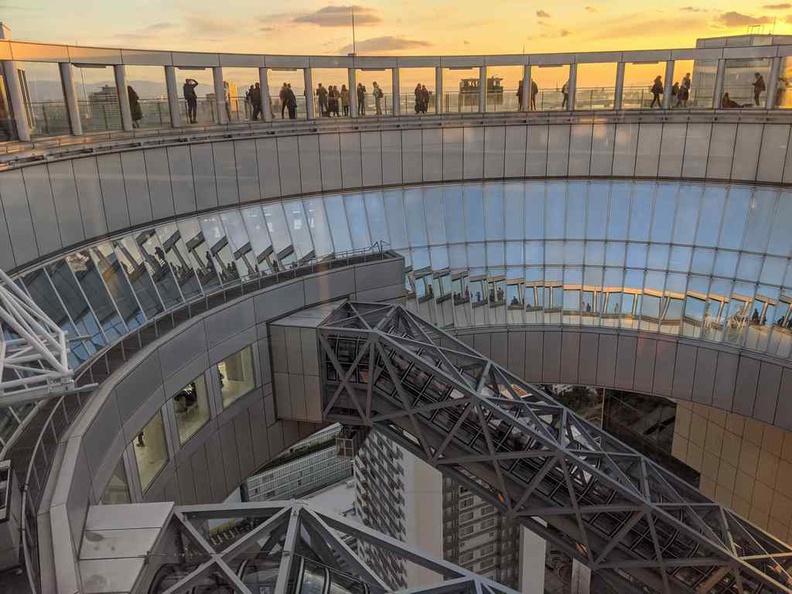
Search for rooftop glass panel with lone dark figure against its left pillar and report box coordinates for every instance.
[124,66,170,128]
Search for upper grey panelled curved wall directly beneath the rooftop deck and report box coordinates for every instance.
[0,112,792,271]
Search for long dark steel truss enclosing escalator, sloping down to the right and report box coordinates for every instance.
[317,302,792,594]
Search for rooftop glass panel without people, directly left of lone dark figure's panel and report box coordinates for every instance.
[72,65,122,132]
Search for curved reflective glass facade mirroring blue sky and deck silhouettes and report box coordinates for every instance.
[10,180,792,364]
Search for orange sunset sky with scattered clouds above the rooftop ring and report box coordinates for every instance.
[6,0,792,54]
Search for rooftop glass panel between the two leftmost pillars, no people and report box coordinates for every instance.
[17,62,71,136]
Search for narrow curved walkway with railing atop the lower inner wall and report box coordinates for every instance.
[14,242,398,593]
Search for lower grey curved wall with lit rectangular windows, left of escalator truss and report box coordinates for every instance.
[44,257,404,592]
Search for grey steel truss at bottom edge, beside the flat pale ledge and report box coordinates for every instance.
[145,500,517,594]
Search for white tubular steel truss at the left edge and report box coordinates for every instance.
[0,270,74,406]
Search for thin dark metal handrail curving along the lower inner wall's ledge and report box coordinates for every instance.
[15,241,390,594]
